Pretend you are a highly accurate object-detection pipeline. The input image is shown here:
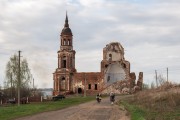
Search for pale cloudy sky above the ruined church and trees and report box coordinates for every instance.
[0,0,180,88]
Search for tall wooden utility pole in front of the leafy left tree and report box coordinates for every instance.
[18,51,21,106]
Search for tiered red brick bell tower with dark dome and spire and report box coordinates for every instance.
[53,12,76,95]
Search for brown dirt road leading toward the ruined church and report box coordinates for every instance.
[17,97,130,120]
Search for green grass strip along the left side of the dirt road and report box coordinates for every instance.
[0,96,95,120]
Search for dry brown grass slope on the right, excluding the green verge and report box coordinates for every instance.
[124,83,180,120]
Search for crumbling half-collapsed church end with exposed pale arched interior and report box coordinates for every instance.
[101,42,143,94]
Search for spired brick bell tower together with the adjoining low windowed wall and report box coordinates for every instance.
[53,15,103,95]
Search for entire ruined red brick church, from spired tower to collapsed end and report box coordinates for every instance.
[53,14,143,96]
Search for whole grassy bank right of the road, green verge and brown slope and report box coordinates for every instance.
[120,87,180,120]
